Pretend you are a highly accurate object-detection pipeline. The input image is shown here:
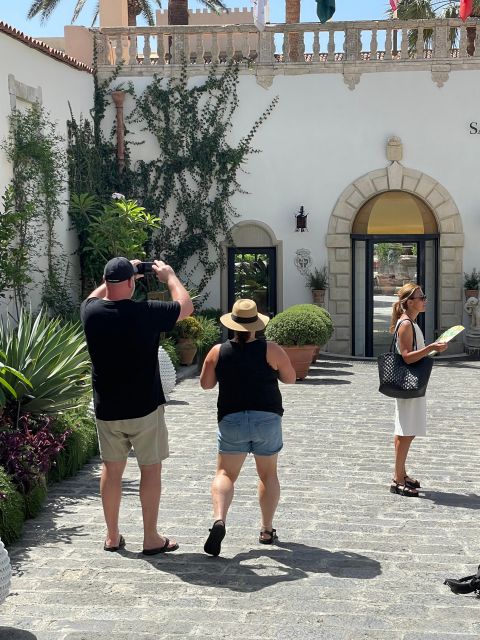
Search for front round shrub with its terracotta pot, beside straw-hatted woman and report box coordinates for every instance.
[265,309,328,380]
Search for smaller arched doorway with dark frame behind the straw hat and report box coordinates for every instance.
[221,220,283,316]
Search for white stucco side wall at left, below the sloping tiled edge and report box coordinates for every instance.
[0,33,93,318]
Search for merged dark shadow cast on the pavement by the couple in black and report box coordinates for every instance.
[120,542,381,593]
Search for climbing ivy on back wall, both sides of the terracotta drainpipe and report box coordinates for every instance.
[68,61,277,292]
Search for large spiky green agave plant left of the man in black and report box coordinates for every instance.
[0,310,90,414]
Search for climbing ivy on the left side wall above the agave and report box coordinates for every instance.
[0,104,73,315]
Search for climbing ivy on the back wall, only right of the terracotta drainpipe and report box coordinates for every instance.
[129,61,277,292]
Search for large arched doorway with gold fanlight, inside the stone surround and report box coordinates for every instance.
[351,191,439,356]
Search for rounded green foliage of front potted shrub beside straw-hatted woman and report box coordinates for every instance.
[265,308,328,347]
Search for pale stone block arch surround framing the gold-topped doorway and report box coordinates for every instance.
[326,162,464,355]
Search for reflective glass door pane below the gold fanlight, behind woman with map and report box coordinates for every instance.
[371,242,418,356]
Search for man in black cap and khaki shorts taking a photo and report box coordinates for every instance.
[80,257,193,555]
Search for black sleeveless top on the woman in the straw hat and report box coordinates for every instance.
[215,340,283,422]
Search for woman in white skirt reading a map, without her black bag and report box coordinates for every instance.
[390,282,448,497]
